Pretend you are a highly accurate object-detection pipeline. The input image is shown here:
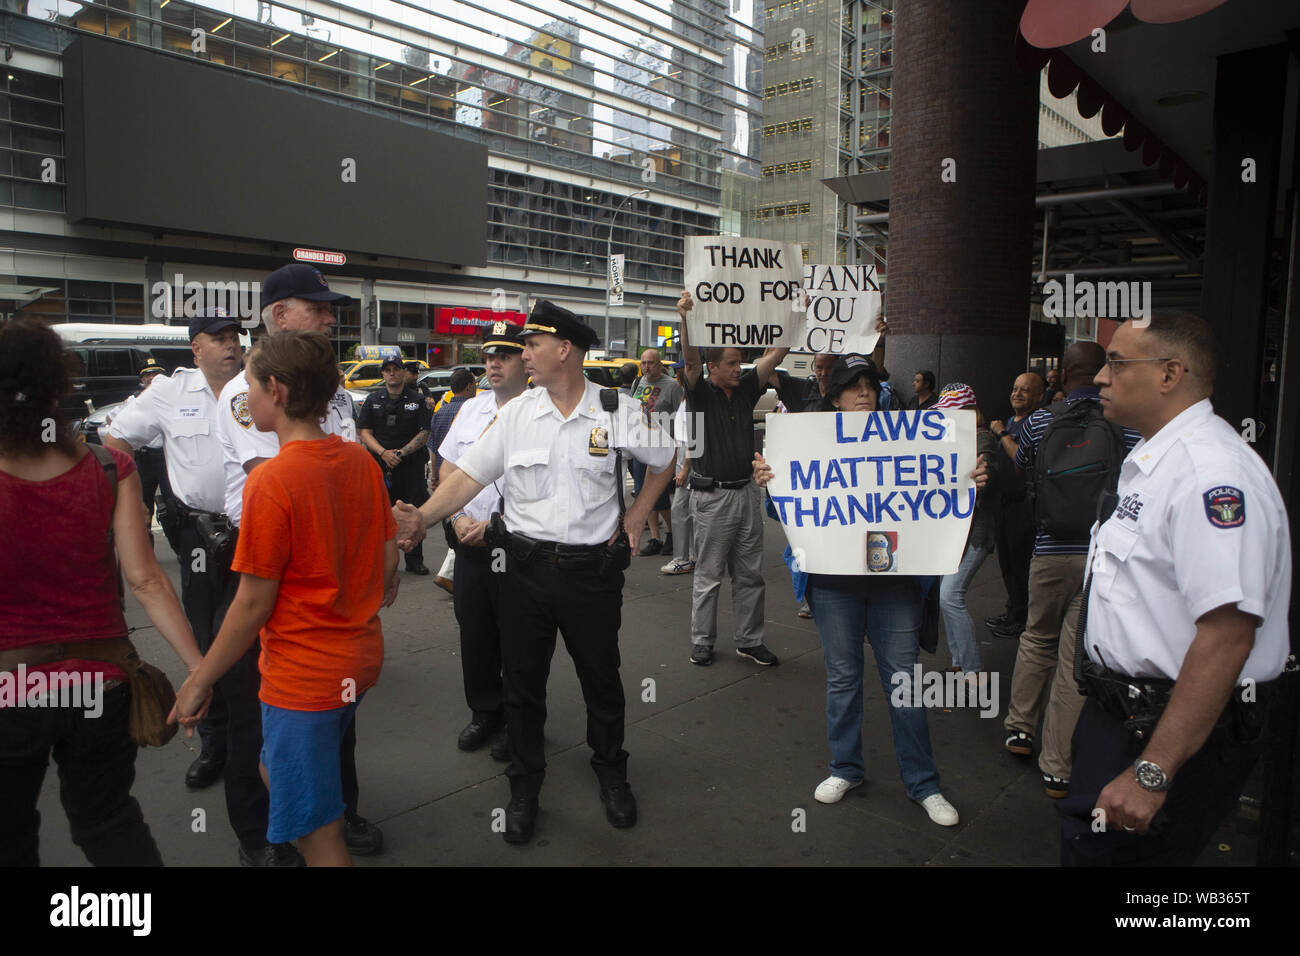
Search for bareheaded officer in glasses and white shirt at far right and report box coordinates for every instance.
[1060,315,1291,866]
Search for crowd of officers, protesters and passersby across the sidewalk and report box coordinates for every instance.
[0,264,1291,866]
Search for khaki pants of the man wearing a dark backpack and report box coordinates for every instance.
[1002,554,1087,780]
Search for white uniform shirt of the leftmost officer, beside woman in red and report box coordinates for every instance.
[108,368,226,512]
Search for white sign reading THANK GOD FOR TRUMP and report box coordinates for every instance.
[686,235,803,349]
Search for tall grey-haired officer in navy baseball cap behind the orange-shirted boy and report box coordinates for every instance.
[208,263,384,866]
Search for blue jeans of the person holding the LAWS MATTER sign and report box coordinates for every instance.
[807,575,939,800]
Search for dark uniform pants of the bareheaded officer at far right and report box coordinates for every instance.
[1057,697,1262,866]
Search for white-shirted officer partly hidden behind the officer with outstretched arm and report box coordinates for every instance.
[438,321,528,761]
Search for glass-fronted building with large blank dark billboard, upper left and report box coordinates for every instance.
[0,0,763,364]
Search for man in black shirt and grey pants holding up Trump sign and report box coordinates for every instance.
[677,290,789,667]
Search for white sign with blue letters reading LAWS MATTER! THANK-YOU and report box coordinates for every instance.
[763,408,976,575]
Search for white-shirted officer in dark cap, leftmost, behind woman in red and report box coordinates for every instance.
[104,308,242,790]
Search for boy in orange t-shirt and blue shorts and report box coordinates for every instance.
[173,332,398,866]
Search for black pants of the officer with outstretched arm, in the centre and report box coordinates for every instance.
[499,557,628,797]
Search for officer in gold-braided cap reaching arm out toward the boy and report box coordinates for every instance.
[394,302,675,843]
